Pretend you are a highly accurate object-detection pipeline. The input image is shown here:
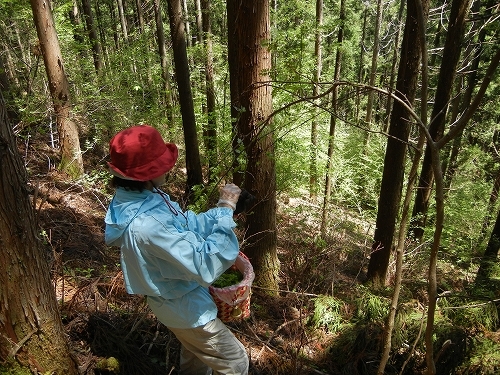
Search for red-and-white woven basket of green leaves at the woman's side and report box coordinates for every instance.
[208,251,255,323]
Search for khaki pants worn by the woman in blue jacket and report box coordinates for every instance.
[169,318,248,375]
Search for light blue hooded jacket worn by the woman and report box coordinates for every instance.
[105,188,239,328]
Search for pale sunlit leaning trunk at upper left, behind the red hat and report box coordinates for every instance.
[30,0,83,178]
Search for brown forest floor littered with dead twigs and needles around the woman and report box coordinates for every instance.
[20,130,494,375]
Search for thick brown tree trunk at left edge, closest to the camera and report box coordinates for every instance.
[0,93,78,375]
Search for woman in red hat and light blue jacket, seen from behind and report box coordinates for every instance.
[105,125,248,375]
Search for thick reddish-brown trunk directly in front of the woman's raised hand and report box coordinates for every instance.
[228,0,279,291]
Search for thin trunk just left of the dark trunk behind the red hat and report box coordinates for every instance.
[153,0,174,125]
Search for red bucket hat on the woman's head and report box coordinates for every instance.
[108,125,179,181]
